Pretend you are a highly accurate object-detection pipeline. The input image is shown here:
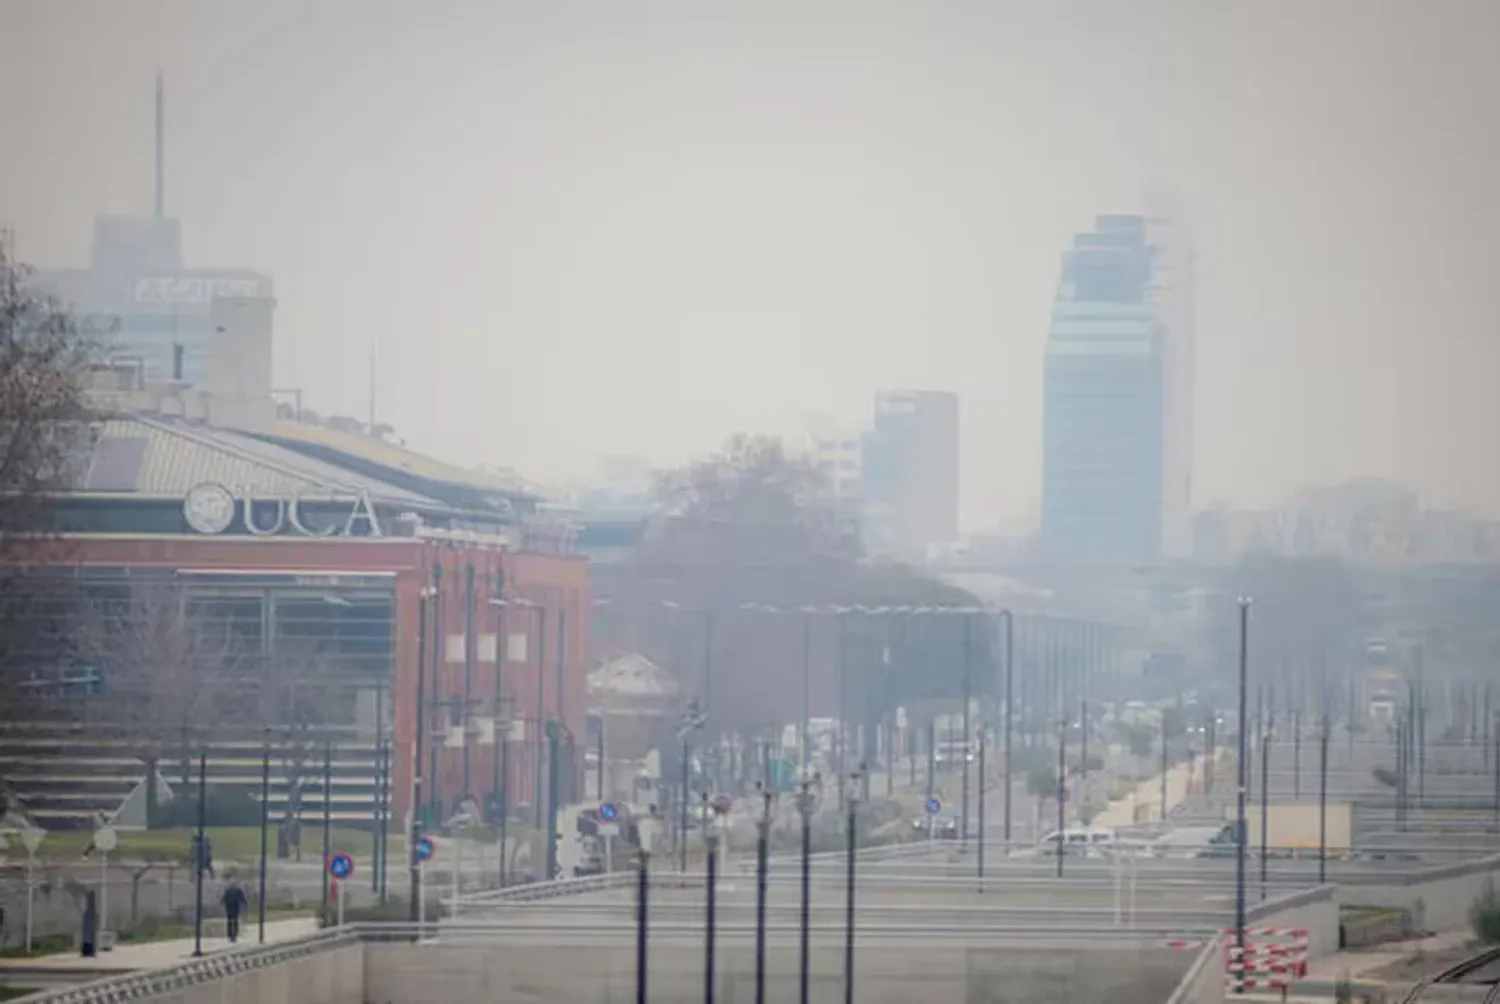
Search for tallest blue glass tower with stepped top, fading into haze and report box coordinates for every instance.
[1043,215,1193,561]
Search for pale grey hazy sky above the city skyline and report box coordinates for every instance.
[0,0,1500,527]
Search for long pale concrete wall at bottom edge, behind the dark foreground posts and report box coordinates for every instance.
[365,941,1193,1004]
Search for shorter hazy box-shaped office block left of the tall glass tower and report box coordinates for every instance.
[860,390,959,561]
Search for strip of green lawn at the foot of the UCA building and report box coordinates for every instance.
[38,824,407,864]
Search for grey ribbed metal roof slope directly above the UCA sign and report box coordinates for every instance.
[78,416,444,509]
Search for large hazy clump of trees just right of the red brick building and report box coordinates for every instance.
[593,435,987,735]
